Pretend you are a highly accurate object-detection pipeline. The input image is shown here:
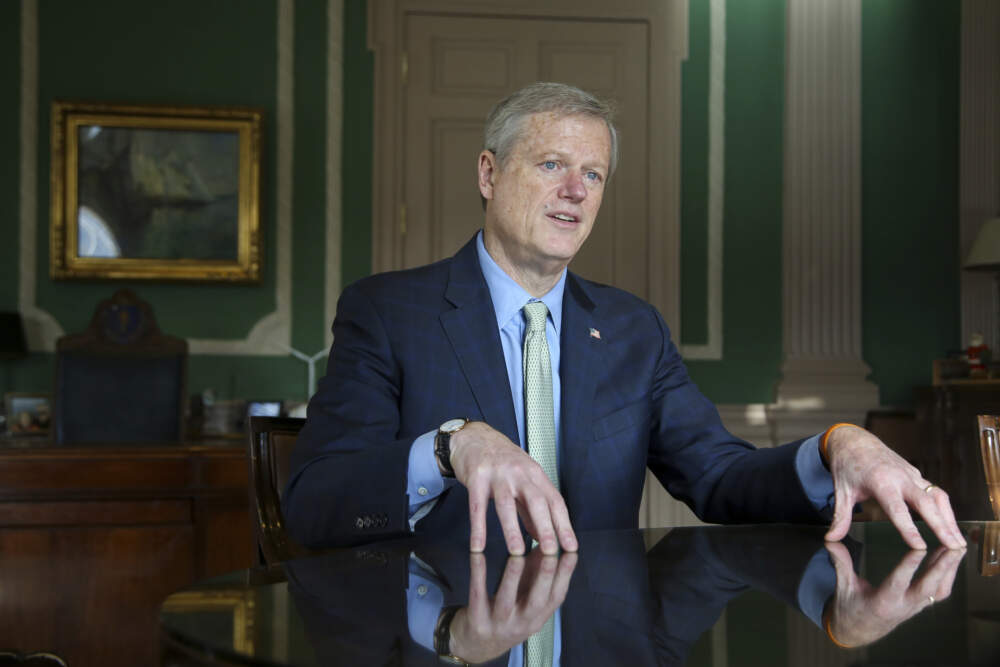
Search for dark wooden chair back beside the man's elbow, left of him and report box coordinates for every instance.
[248,417,313,568]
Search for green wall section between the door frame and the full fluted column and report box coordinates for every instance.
[675,0,785,403]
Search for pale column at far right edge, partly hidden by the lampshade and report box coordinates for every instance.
[959,0,1000,356]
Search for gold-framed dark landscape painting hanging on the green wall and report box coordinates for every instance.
[50,101,261,283]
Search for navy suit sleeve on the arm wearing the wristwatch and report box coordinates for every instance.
[282,285,413,548]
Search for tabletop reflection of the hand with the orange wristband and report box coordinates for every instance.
[824,542,965,648]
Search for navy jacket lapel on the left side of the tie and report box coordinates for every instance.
[441,238,518,443]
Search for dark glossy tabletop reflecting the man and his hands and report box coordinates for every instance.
[160,522,1000,667]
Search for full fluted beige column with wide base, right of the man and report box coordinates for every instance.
[770,0,878,442]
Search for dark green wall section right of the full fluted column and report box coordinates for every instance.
[861,0,961,405]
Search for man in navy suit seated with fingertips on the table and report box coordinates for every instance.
[285,84,964,554]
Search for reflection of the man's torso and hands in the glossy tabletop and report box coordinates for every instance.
[286,525,976,667]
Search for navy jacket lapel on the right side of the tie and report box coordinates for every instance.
[559,273,604,500]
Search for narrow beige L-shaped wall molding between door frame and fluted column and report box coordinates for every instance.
[681,0,726,360]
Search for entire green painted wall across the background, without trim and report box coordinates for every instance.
[0,0,960,405]
